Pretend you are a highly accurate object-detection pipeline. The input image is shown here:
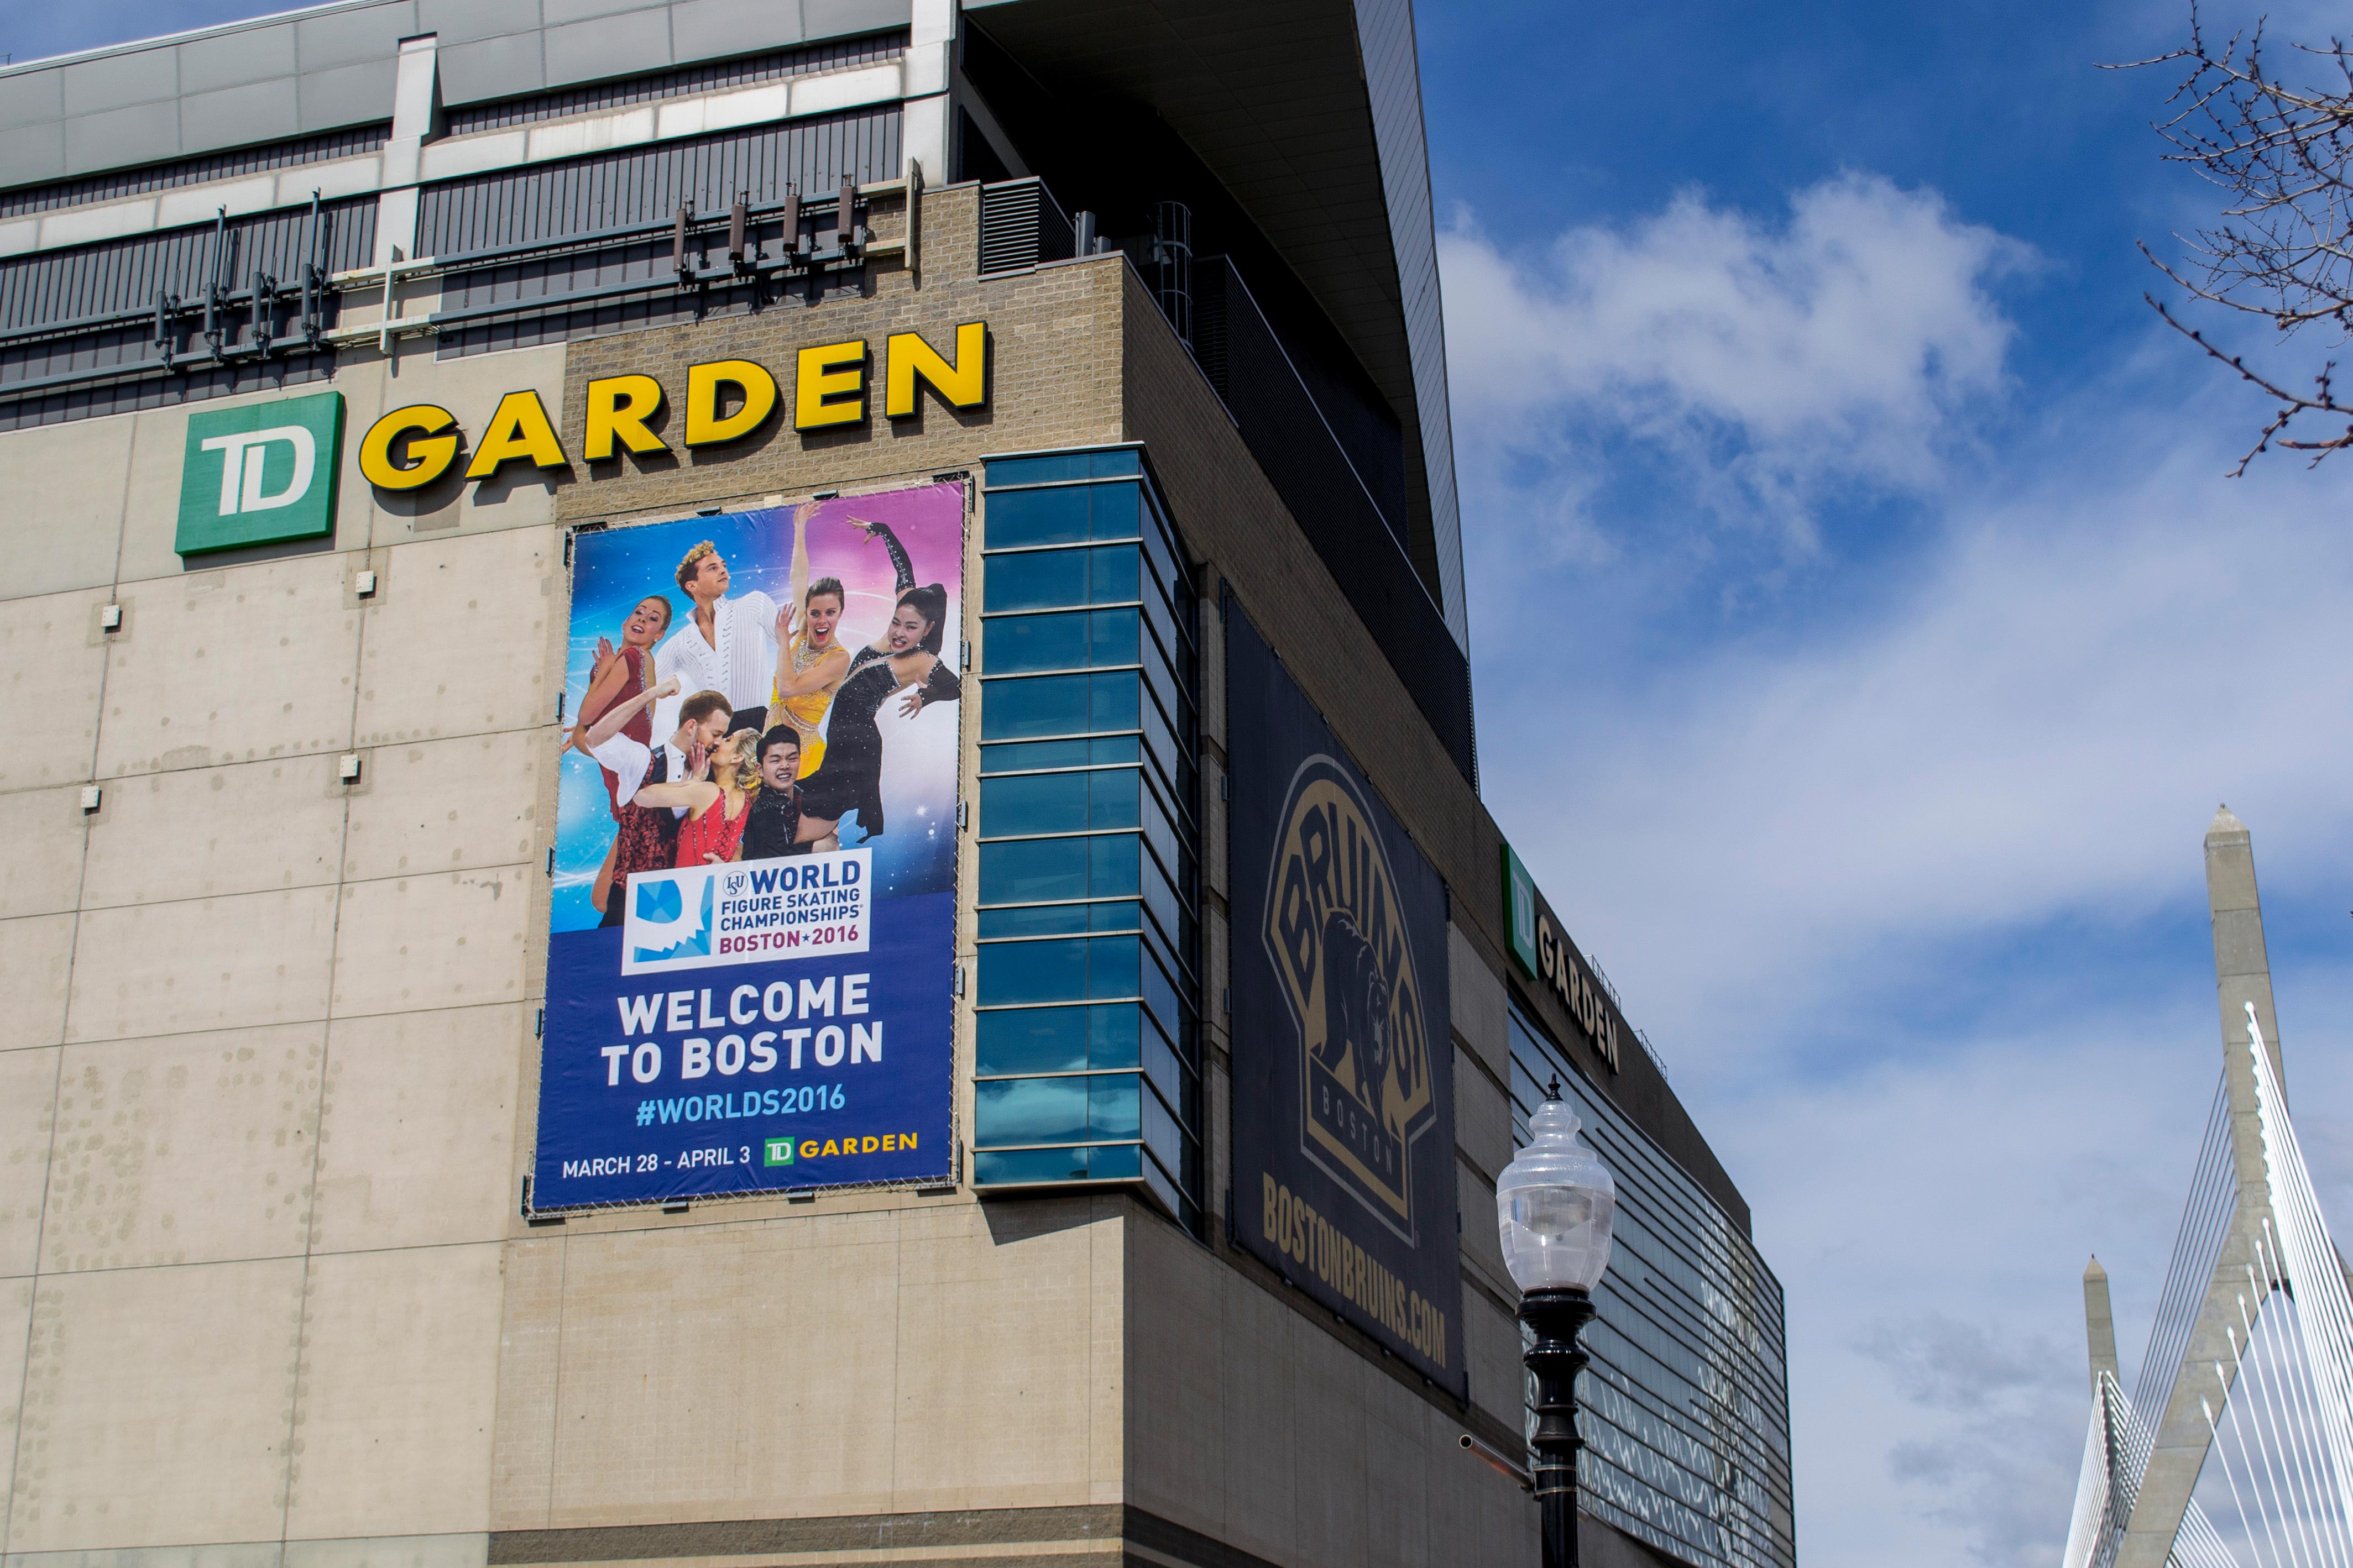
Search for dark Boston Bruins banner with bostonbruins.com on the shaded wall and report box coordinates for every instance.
[1226,606,1468,1399]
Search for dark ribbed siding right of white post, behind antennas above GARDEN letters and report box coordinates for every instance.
[419,103,899,358]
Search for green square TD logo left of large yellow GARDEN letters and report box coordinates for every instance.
[172,392,343,555]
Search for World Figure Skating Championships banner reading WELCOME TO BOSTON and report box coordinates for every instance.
[530,484,965,1210]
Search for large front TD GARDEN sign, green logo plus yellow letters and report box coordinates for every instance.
[174,322,989,555]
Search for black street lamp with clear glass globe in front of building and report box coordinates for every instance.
[1494,1079,1617,1568]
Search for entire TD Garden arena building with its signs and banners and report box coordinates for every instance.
[0,0,1795,1568]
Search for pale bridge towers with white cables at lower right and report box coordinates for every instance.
[2066,806,2353,1568]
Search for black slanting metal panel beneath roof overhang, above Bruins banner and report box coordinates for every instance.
[1193,256,1476,783]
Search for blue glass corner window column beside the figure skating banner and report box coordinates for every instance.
[972,449,1202,1232]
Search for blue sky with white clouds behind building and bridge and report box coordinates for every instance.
[14,0,2353,1568]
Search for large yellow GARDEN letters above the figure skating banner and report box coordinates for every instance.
[360,322,989,491]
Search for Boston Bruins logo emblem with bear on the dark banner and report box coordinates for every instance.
[1261,757,1435,1246]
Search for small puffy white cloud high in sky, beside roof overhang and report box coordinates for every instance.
[1440,174,2033,536]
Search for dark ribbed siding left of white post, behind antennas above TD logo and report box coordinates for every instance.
[0,197,377,430]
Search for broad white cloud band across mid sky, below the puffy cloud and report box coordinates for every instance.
[1482,416,2353,1067]
